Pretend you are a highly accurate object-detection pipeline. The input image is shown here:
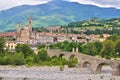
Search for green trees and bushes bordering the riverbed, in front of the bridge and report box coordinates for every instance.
[0,38,78,67]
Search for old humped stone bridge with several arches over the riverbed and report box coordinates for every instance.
[48,49,120,76]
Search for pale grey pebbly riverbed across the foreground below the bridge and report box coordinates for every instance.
[0,66,120,80]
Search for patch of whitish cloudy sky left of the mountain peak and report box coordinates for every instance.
[0,0,50,10]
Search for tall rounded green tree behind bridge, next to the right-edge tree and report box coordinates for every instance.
[101,40,114,59]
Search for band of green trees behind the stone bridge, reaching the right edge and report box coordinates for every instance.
[49,34,120,59]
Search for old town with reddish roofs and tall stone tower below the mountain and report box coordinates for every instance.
[0,16,110,50]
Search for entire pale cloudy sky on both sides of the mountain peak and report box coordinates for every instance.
[0,0,120,10]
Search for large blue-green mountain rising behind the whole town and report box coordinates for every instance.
[0,0,120,31]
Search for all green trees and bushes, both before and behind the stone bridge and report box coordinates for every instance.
[0,35,120,67]
